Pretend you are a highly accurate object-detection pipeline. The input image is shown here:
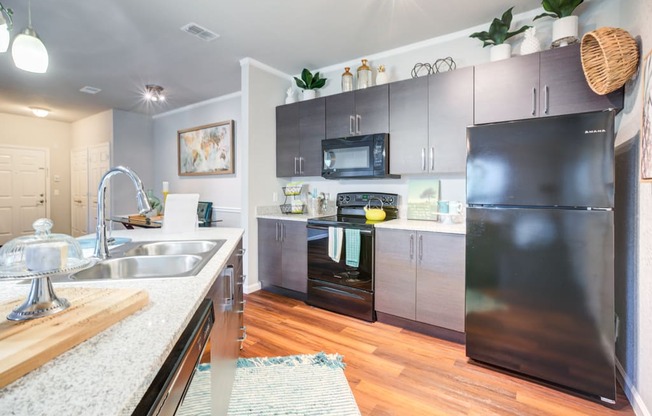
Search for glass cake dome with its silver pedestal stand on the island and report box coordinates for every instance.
[0,218,94,321]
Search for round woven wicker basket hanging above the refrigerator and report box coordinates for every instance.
[581,27,638,95]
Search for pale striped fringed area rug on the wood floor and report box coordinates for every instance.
[177,352,360,416]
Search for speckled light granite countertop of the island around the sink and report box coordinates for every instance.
[0,228,243,416]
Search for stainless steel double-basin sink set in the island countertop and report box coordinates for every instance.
[52,240,226,282]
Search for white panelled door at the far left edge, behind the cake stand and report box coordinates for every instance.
[0,146,48,245]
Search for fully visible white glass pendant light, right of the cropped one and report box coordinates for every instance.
[11,0,49,74]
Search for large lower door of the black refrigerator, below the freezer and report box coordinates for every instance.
[465,208,616,400]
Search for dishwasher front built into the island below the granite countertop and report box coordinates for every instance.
[132,299,215,416]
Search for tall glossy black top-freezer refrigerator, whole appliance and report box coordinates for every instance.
[465,111,616,403]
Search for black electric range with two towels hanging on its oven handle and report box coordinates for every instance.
[306,192,398,321]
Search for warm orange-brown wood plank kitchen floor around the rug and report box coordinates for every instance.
[241,291,634,416]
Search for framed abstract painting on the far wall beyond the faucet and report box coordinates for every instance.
[177,120,235,176]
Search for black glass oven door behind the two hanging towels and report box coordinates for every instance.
[307,224,374,292]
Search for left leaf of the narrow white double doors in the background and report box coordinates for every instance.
[70,148,88,237]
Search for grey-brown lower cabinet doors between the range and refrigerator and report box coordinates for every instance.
[375,229,465,332]
